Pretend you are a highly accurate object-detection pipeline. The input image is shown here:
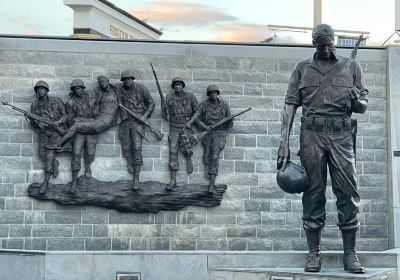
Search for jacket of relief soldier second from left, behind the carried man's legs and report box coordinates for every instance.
[65,92,94,125]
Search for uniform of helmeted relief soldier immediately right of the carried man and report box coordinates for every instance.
[118,83,154,170]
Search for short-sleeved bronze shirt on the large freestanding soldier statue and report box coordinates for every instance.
[285,54,368,118]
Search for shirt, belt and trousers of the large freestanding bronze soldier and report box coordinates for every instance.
[285,52,368,231]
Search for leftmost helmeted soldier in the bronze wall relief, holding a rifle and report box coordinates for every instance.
[30,81,67,194]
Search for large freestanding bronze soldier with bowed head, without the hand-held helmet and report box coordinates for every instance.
[277,24,368,273]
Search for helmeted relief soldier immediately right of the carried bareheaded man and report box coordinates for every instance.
[118,70,154,190]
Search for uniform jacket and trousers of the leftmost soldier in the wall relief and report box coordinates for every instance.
[31,96,66,177]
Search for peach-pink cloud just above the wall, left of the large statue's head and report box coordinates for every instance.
[215,23,269,42]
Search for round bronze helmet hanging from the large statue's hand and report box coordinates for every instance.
[276,161,310,194]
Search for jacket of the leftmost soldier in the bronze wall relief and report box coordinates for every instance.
[31,96,66,137]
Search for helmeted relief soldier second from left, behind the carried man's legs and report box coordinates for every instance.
[65,79,98,193]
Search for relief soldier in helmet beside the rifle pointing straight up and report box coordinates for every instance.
[165,77,198,190]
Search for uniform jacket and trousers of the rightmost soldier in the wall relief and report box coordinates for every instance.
[199,99,232,175]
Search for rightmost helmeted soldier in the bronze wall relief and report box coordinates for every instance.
[194,85,233,193]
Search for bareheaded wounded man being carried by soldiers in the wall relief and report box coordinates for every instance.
[49,76,118,149]
